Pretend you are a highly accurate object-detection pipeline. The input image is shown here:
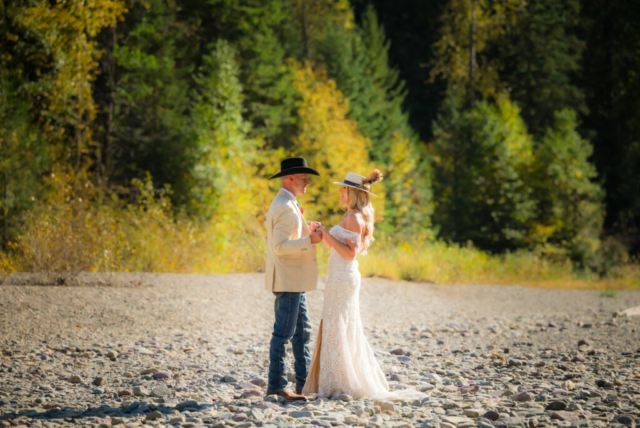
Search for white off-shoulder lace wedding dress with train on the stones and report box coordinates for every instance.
[303,225,428,400]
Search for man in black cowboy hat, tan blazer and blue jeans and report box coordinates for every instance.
[265,158,322,401]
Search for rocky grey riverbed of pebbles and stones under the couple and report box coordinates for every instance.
[0,274,640,428]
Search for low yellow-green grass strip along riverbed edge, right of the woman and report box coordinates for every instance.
[360,237,640,289]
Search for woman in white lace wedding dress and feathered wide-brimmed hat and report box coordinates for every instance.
[303,170,428,400]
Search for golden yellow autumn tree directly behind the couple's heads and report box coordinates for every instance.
[290,64,385,225]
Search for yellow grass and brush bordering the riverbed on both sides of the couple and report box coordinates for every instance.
[0,174,640,290]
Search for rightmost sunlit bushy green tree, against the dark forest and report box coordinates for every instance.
[530,109,604,268]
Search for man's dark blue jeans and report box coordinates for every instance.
[267,292,311,392]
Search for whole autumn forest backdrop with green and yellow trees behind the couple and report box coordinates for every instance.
[0,0,640,287]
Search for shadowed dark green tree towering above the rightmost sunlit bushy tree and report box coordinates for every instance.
[496,0,586,137]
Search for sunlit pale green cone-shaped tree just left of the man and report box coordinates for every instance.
[190,40,268,226]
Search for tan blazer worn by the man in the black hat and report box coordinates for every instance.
[264,190,318,292]
